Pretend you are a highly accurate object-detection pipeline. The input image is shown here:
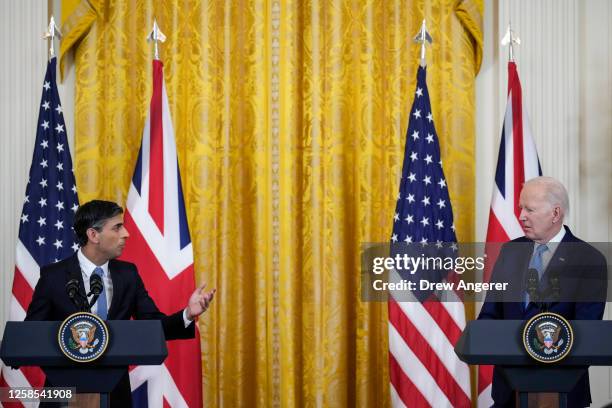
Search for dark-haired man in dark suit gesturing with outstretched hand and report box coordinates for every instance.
[25,200,215,407]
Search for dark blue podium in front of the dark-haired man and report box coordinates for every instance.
[0,320,168,407]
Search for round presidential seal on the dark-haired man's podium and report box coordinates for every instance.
[57,312,109,363]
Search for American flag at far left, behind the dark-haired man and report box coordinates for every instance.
[0,58,79,406]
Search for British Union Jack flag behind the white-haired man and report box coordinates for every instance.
[478,61,542,407]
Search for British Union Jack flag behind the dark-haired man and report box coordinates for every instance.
[122,60,202,407]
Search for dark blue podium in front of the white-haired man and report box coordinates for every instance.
[455,320,612,407]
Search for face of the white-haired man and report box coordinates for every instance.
[519,184,561,243]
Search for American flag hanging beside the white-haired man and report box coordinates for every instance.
[389,67,470,407]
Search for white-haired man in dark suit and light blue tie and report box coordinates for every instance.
[478,177,607,407]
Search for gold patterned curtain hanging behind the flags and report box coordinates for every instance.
[61,0,482,407]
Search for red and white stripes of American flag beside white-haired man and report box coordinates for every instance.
[389,272,471,408]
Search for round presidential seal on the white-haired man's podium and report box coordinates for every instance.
[523,312,574,363]
